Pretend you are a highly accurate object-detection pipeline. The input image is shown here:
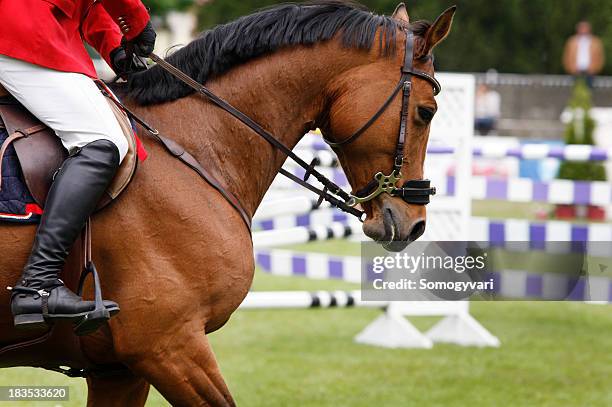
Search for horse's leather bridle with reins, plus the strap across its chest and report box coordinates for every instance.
[112,29,441,228]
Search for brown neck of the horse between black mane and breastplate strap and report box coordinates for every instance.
[152,43,366,216]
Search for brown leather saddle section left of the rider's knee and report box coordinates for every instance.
[0,102,68,207]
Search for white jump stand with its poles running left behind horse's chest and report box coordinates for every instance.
[241,74,500,348]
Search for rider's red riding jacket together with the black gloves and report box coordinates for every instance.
[0,0,149,77]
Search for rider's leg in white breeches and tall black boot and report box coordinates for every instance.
[0,56,128,334]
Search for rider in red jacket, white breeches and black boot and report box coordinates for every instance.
[0,0,156,327]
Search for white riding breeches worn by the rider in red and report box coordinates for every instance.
[0,55,128,160]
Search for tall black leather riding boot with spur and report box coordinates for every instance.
[11,140,119,334]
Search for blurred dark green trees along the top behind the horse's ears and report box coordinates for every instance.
[192,0,612,74]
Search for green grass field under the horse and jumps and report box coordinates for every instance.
[0,273,612,407]
